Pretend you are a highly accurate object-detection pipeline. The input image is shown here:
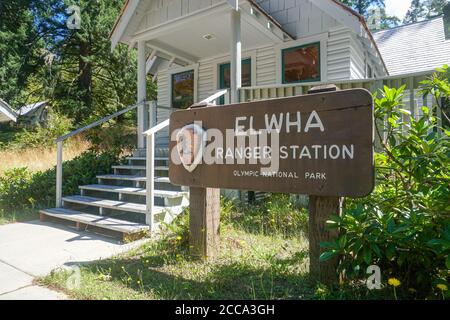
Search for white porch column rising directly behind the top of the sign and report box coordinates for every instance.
[230,5,242,103]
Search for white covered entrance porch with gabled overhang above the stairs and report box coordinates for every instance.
[131,1,294,148]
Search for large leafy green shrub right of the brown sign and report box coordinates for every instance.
[321,66,450,298]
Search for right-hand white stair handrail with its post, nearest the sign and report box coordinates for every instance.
[143,90,229,231]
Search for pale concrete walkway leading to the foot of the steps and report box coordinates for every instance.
[0,221,148,300]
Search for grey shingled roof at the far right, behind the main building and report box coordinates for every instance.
[373,16,450,75]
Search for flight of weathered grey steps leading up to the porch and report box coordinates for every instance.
[41,148,189,241]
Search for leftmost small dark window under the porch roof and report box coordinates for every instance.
[172,70,194,109]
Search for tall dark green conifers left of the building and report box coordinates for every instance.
[0,0,154,125]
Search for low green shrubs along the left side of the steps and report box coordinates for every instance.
[0,151,120,209]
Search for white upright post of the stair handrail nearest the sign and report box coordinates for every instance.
[145,133,155,232]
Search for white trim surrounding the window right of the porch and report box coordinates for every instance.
[275,32,328,84]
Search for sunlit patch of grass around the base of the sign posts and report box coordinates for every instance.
[38,198,390,300]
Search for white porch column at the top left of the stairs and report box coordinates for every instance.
[137,41,149,149]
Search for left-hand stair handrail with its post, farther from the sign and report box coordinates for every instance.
[55,101,148,208]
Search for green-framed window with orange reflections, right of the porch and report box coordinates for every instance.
[281,42,321,83]
